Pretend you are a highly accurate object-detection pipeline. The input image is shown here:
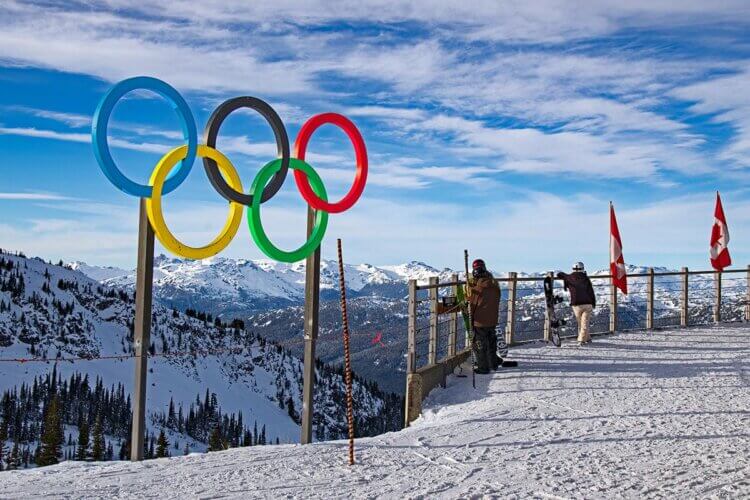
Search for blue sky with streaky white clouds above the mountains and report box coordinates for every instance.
[0,0,750,271]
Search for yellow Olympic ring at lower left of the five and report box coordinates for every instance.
[146,145,243,259]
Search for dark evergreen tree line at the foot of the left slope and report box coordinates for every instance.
[0,364,279,470]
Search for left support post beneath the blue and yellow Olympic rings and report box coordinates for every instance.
[130,198,154,462]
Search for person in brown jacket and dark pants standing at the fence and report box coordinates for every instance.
[468,259,501,374]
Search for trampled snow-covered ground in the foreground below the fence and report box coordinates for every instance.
[0,325,750,498]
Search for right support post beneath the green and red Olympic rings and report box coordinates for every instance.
[300,207,320,444]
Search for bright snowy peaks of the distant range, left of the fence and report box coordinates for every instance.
[68,255,458,317]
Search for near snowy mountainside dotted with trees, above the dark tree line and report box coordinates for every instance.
[0,253,401,458]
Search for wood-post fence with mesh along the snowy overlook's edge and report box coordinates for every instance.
[405,266,750,425]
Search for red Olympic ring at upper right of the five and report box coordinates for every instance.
[294,113,367,214]
